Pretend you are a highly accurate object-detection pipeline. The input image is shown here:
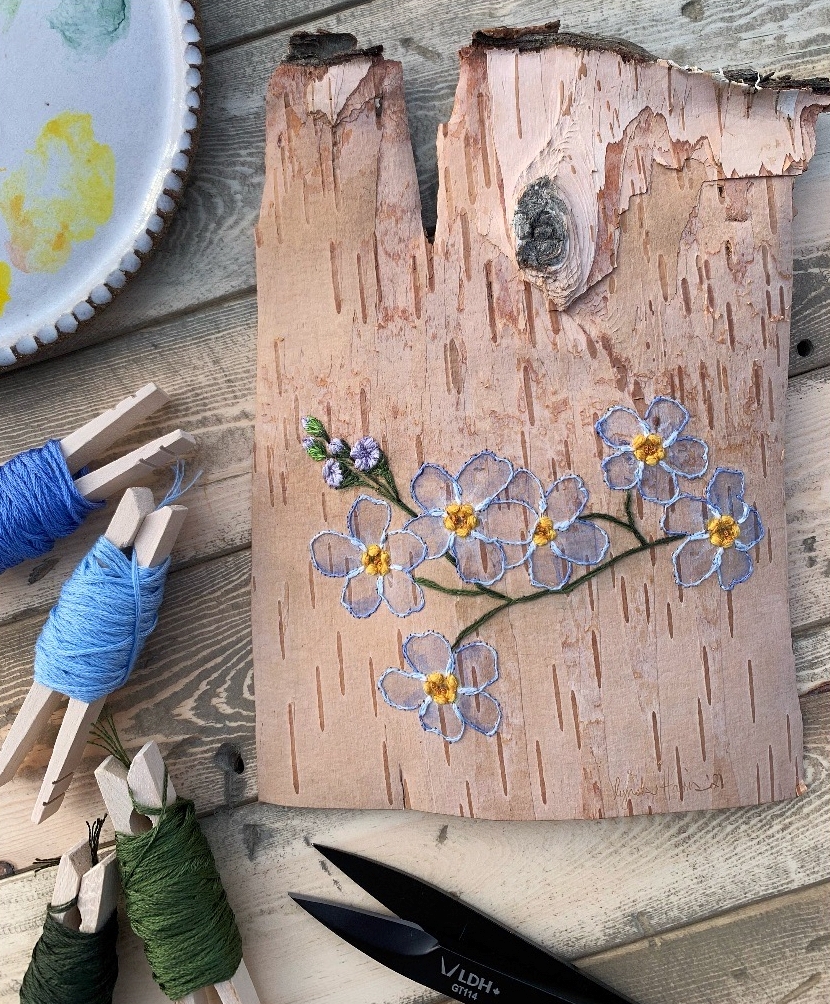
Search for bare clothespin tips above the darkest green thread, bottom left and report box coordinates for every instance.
[52,839,118,934]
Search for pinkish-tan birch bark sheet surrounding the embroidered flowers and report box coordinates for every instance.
[254,25,830,818]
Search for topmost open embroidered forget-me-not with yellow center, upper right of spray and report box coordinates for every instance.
[595,398,709,505]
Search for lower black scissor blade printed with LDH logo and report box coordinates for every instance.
[291,895,592,1004]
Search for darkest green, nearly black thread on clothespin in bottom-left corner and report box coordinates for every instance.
[20,907,118,1004]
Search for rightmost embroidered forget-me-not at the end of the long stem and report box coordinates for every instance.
[660,467,764,589]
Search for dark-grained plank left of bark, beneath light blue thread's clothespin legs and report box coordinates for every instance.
[0,551,257,868]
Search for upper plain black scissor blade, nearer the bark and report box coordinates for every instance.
[314,843,631,1004]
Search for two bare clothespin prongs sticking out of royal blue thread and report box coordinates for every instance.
[60,384,196,502]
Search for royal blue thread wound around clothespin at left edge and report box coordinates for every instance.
[0,440,104,573]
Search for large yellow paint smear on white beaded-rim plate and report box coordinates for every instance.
[0,111,115,272]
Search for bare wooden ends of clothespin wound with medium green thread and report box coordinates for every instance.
[95,742,260,1004]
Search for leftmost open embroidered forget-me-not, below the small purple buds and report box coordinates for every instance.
[310,495,427,617]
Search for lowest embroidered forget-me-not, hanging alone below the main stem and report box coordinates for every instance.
[377,631,502,743]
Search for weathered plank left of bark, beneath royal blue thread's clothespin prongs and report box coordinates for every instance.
[0,297,256,622]
